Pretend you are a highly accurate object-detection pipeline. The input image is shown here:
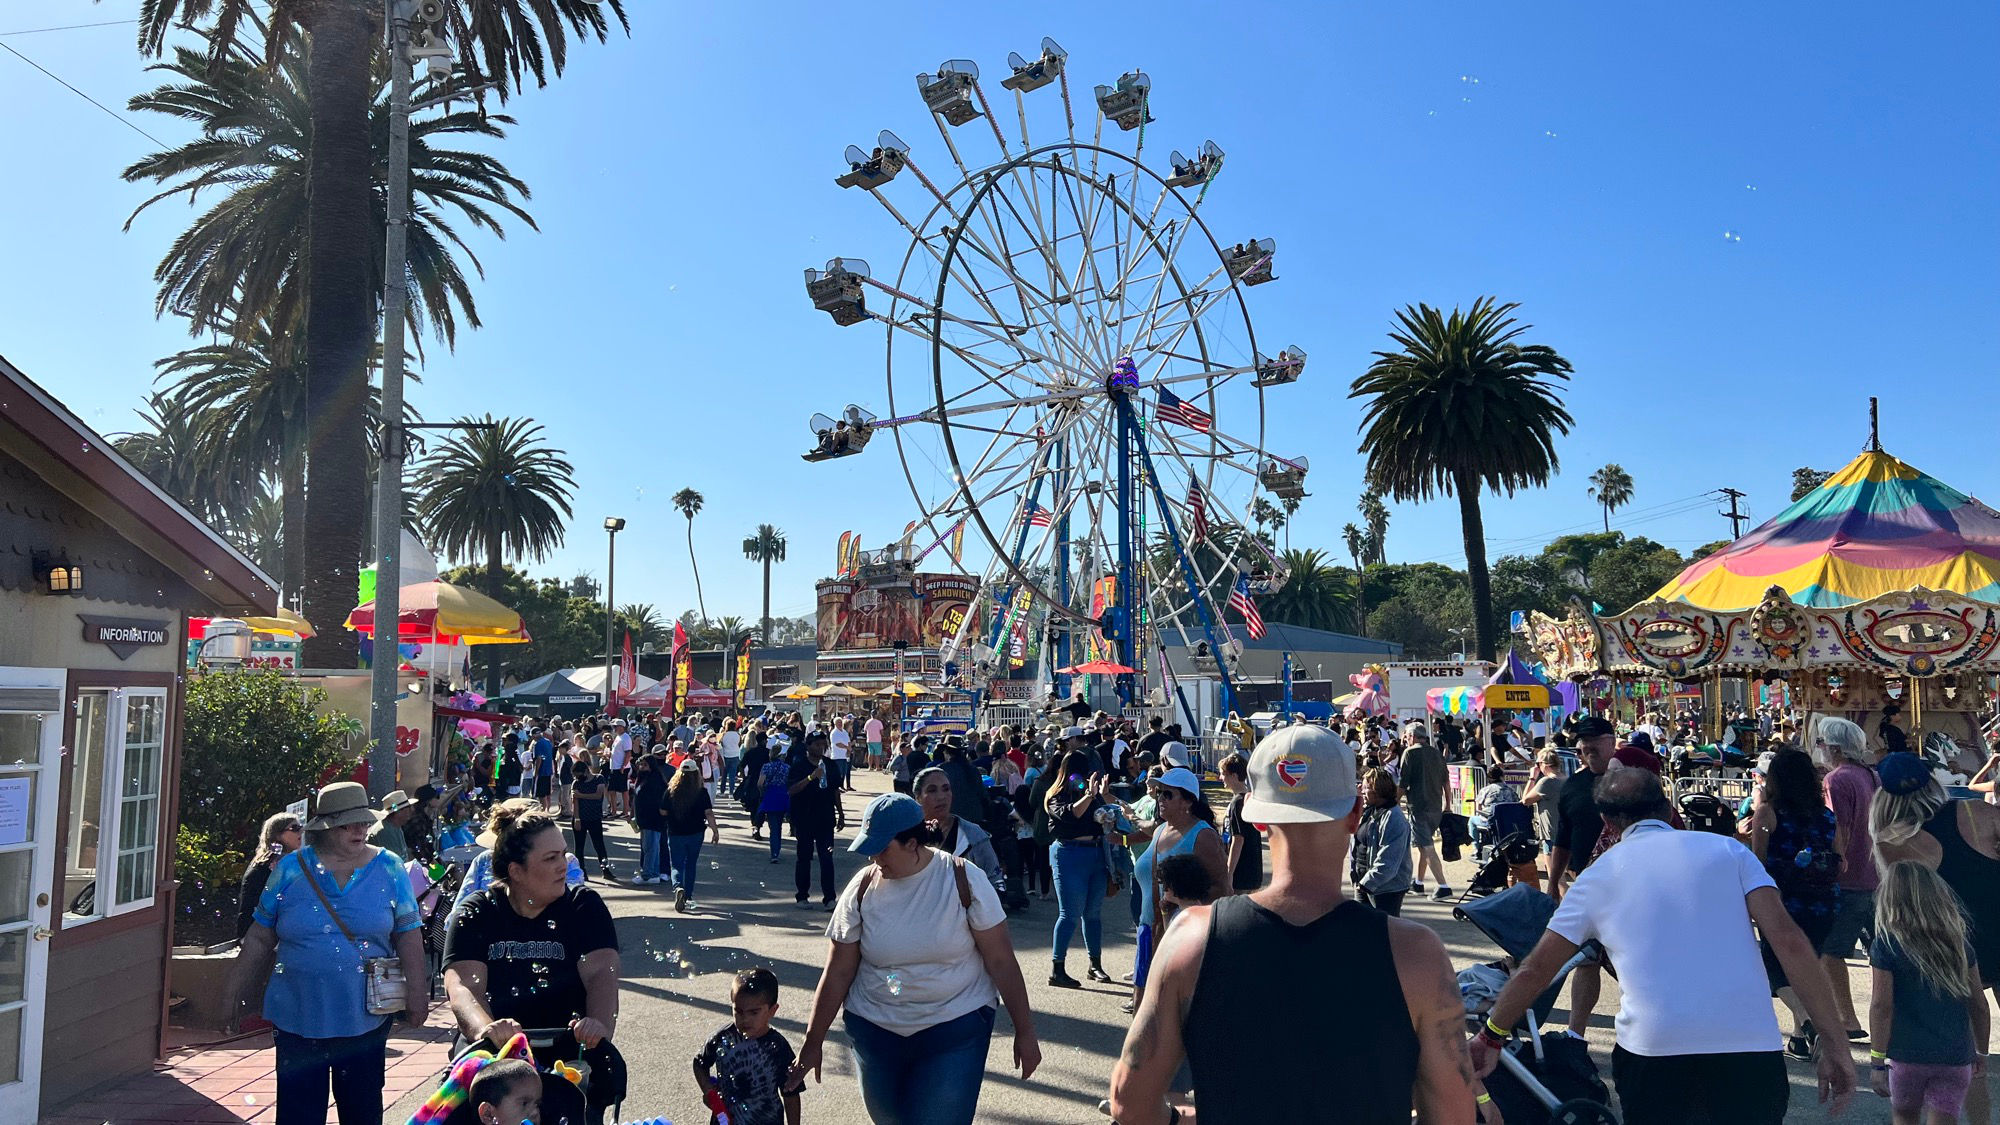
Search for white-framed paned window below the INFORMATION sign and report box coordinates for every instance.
[62,689,166,927]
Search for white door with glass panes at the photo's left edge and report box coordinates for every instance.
[0,667,64,1121]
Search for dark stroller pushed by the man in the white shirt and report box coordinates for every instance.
[1452,887,1618,1125]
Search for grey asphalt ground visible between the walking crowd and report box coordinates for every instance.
[384,771,1890,1125]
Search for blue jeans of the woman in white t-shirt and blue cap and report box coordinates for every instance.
[846,1007,994,1125]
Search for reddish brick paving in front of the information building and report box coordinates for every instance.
[42,1005,452,1125]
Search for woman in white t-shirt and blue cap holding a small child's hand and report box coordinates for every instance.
[798,793,1042,1125]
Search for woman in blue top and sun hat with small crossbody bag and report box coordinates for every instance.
[230,781,430,1125]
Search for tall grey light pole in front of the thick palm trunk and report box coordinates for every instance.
[368,0,416,797]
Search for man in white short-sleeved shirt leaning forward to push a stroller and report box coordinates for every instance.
[1472,769,1854,1125]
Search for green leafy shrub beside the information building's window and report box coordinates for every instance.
[180,669,356,840]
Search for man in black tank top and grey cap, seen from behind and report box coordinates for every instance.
[1110,725,1474,1125]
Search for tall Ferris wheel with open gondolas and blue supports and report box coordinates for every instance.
[804,38,1308,707]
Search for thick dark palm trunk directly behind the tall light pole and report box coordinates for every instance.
[302,2,376,669]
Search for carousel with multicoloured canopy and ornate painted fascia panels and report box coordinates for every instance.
[1528,444,2000,759]
